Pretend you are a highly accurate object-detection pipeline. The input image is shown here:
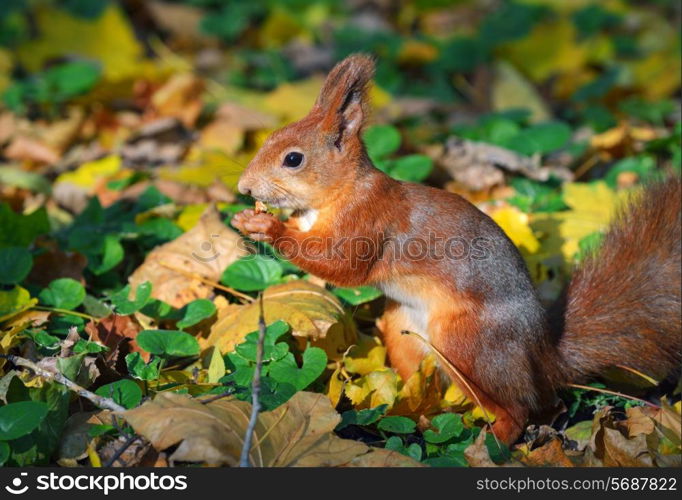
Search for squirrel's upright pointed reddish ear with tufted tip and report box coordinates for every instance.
[315,54,374,149]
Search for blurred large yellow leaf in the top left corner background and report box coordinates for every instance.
[17,2,143,81]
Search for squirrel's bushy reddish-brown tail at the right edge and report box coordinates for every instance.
[555,176,682,383]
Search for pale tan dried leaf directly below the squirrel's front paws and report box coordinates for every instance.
[128,206,248,308]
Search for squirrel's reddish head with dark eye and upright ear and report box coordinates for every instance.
[238,54,374,210]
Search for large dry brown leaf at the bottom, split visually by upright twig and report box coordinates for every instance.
[123,392,369,467]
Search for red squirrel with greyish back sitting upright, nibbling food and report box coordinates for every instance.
[232,54,682,443]
